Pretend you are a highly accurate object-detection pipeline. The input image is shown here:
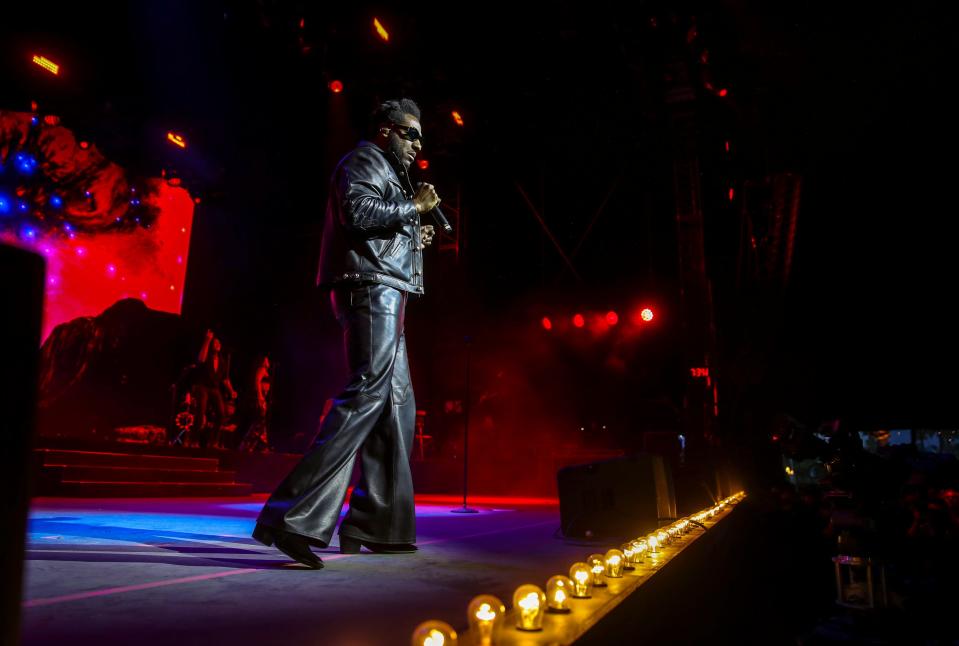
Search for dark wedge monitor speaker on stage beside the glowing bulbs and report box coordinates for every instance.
[556,454,676,541]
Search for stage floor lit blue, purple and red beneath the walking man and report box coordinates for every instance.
[22,495,595,646]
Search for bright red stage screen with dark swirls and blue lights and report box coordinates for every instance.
[0,111,194,338]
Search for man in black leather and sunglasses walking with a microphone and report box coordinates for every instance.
[253,99,440,568]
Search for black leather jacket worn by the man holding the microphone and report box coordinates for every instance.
[317,141,423,294]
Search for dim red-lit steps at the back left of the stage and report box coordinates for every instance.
[34,449,253,498]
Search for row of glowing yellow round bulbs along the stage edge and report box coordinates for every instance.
[411,492,746,646]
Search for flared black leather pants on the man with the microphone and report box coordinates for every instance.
[257,284,416,547]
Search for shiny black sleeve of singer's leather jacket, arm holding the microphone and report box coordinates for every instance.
[335,156,416,235]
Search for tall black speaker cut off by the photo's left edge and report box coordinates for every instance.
[0,244,44,645]
